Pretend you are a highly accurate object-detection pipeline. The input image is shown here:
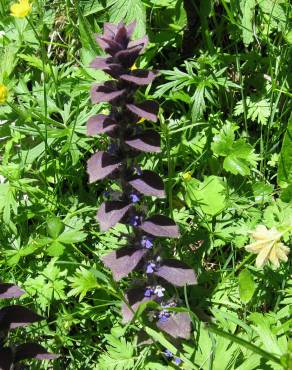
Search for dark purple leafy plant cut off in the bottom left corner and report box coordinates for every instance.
[0,283,58,370]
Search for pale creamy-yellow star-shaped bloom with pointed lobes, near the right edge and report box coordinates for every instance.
[245,225,289,268]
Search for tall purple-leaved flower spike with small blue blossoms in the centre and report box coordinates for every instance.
[87,22,196,339]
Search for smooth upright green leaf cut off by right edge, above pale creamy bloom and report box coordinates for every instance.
[278,114,292,187]
